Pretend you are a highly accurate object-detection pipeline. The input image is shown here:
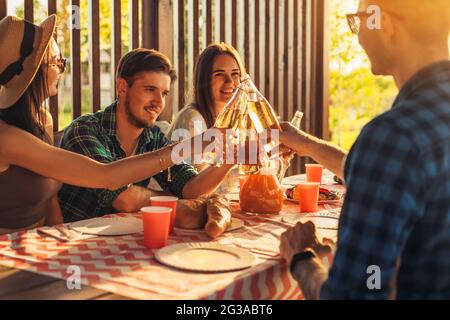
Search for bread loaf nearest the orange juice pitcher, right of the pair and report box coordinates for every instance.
[205,195,231,239]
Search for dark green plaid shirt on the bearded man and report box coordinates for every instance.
[59,103,197,222]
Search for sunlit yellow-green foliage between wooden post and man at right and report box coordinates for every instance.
[330,0,397,150]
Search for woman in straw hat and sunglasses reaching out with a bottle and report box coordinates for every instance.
[0,15,232,234]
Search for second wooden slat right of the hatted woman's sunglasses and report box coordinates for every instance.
[88,0,101,112]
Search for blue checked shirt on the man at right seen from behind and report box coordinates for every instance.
[321,61,450,299]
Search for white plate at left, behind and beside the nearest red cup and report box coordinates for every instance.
[69,217,144,236]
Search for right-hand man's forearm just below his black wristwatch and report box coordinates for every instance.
[293,257,328,300]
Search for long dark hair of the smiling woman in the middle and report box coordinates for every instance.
[191,42,246,128]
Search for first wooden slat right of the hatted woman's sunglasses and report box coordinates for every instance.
[71,0,81,119]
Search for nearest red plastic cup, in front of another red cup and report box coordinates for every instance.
[141,207,172,249]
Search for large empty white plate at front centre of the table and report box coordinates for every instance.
[155,242,255,272]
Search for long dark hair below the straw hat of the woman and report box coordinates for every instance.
[0,65,50,142]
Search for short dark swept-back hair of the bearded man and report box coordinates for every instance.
[116,48,177,87]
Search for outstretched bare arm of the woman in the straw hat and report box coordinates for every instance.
[0,125,207,190]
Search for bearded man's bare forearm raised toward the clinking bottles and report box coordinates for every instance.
[183,165,233,199]
